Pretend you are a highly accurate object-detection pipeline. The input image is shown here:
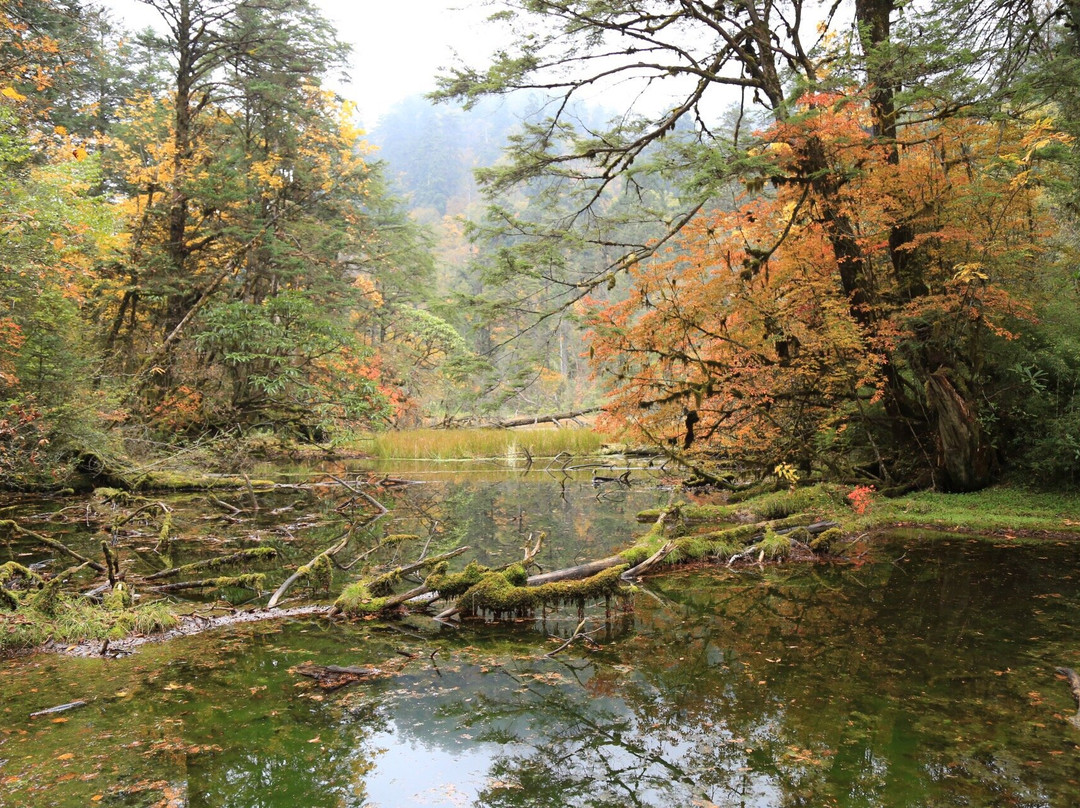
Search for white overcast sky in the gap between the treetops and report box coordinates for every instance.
[102,0,501,129]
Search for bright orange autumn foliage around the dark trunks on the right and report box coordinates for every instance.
[589,94,1059,469]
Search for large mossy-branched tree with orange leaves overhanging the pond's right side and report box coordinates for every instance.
[443,0,1080,489]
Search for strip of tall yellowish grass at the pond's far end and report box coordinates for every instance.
[370,428,604,460]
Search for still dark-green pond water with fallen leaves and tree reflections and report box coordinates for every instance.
[0,467,1080,808]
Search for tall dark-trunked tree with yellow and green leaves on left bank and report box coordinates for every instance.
[92,1,424,436]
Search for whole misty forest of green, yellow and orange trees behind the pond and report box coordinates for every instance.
[0,0,1080,490]
